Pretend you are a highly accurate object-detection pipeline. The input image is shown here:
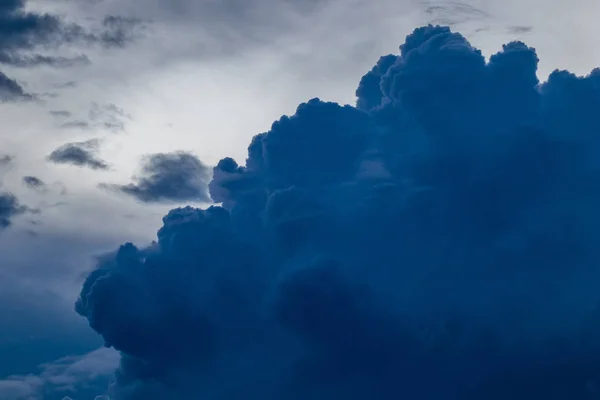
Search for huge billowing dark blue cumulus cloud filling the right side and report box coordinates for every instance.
[76,26,600,400]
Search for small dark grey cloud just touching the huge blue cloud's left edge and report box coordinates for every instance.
[100,152,210,203]
